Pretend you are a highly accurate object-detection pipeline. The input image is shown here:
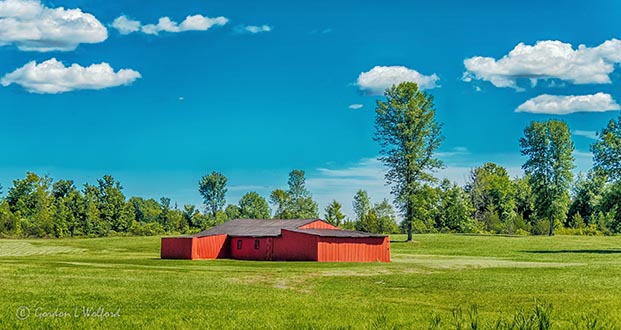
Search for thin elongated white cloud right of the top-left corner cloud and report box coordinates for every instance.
[111,15,229,35]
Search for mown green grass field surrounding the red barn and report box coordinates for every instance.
[0,235,621,329]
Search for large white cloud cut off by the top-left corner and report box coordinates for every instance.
[0,0,108,52]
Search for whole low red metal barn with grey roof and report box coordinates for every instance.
[161,219,390,262]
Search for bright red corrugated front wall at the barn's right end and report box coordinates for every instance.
[317,237,390,262]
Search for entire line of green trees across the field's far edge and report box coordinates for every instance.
[0,82,621,240]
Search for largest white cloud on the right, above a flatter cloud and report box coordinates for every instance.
[462,39,621,90]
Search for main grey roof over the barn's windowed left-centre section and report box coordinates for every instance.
[192,219,323,237]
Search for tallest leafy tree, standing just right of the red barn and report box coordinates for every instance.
[375,82,443,241]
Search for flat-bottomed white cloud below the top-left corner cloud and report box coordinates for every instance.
[0,58,141,94]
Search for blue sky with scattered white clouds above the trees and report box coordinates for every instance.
[0,0,621,219]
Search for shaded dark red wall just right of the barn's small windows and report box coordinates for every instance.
[272,229,317,261]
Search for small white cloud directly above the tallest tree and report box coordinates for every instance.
[357,66,440,95]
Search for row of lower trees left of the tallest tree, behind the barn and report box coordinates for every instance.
[0,170,398,238]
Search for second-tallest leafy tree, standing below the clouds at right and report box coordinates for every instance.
[520,120,574,236]
